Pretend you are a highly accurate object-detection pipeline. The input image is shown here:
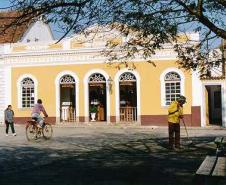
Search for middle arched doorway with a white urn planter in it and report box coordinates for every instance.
[88,73,107,121]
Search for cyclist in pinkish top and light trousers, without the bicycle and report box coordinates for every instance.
[31,99,48,128]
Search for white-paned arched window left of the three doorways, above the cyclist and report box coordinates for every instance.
[21,77,35,108]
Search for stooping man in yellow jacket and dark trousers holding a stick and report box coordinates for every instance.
[168,96,186,149]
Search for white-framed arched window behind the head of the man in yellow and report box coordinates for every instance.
[164,72,181,105]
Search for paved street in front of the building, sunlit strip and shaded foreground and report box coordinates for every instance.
[0,125,226,185]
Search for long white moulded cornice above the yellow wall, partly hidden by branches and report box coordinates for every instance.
[0,44,177,66]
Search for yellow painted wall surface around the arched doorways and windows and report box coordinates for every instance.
[12,61,192,117]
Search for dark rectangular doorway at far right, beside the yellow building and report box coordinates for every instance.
[205,85,222,125]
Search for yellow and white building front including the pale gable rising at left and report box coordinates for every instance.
[0,22,226,126]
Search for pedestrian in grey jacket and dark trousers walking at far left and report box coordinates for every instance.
[5,105,16,136]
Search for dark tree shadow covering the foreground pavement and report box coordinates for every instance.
[0,137,221,185]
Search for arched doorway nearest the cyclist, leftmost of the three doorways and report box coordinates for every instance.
[60,75,76,122]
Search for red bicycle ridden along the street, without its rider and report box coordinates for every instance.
[26,120,53,141]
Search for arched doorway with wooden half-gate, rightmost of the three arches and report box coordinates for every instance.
[119,72,137,122]
